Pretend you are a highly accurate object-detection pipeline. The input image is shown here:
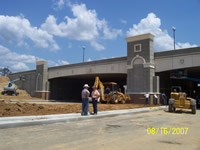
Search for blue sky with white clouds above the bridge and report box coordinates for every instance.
[0,0,200,72]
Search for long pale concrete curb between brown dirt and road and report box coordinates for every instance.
[0,106,167,129]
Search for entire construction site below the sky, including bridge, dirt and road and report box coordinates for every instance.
[0,33,200,150]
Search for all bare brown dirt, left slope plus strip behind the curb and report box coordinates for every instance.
[0,76,152,117]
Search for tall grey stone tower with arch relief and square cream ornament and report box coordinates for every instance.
[126,33,159,103]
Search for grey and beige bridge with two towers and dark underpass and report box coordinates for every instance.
[9,34,200,103]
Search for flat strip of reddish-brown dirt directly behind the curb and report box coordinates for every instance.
[0,101,152,117]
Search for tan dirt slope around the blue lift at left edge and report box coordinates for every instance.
[0,76,36,100]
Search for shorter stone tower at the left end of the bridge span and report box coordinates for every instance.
[35,61,49,100]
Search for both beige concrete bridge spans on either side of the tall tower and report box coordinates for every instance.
[45,47,200,79]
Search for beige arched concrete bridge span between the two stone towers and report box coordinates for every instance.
[48,57,127,79]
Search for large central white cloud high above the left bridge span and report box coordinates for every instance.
[41,3,122,50]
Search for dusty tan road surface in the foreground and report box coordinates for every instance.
[0,110,200,150]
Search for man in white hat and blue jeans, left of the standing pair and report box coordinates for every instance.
[81,84,90,116]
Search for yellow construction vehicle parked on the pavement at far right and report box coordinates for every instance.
[169,87,196,114]
